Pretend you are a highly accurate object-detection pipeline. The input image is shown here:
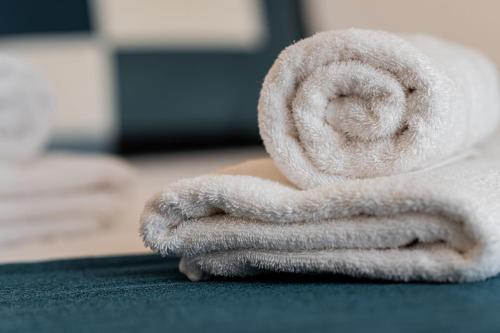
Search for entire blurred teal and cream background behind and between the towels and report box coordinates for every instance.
[0,0,500,261]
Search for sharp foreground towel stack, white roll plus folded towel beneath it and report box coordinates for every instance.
[141,29,500,282]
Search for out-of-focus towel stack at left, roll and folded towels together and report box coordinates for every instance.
[0,56,132,246]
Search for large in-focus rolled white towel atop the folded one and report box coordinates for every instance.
[259,29,500,188]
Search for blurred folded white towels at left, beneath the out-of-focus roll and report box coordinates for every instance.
[0,153,133,246]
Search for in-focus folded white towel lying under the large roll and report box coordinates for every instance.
[142,142,500,282]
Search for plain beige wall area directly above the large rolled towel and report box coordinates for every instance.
[304,0,500,64]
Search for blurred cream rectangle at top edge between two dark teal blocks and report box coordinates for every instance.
[94,0,265,48]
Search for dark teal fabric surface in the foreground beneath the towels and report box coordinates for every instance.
[0,255,500,333]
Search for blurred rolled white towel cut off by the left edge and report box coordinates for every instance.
[0,55,54,162]
